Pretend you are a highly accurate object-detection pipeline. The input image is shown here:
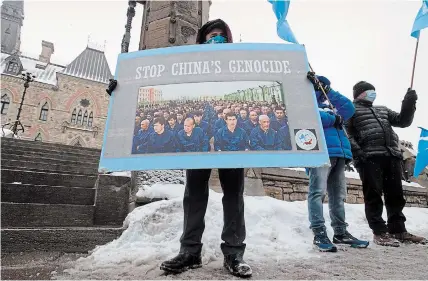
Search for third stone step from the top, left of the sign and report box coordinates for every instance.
[1,159,98,175]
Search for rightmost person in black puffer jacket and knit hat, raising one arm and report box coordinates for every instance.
[346,81,426,247]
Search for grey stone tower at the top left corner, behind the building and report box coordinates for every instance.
[1,1,24,54]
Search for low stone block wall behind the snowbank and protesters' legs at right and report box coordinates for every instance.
[256,168,428,208]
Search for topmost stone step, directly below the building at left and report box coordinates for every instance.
[2,138,101,155]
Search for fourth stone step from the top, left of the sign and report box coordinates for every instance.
[1,167,97,188]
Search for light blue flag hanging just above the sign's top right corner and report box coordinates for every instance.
[268,0,298,44]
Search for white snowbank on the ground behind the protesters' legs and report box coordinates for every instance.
[56,184,428,279]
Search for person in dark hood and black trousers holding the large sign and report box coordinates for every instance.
[160,19,252,277]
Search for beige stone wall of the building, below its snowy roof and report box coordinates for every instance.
[1,73,109,148]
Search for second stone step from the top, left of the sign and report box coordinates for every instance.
[1,145,100,162]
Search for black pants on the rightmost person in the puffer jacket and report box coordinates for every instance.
[359,156,406,234]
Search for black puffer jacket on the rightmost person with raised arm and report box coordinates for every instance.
[346,99,416,161]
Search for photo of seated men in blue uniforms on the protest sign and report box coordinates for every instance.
[132,81,291,154]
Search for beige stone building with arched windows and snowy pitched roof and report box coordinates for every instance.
[0,1,113,148]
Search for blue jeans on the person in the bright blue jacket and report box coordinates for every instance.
[308,157,348,235]
